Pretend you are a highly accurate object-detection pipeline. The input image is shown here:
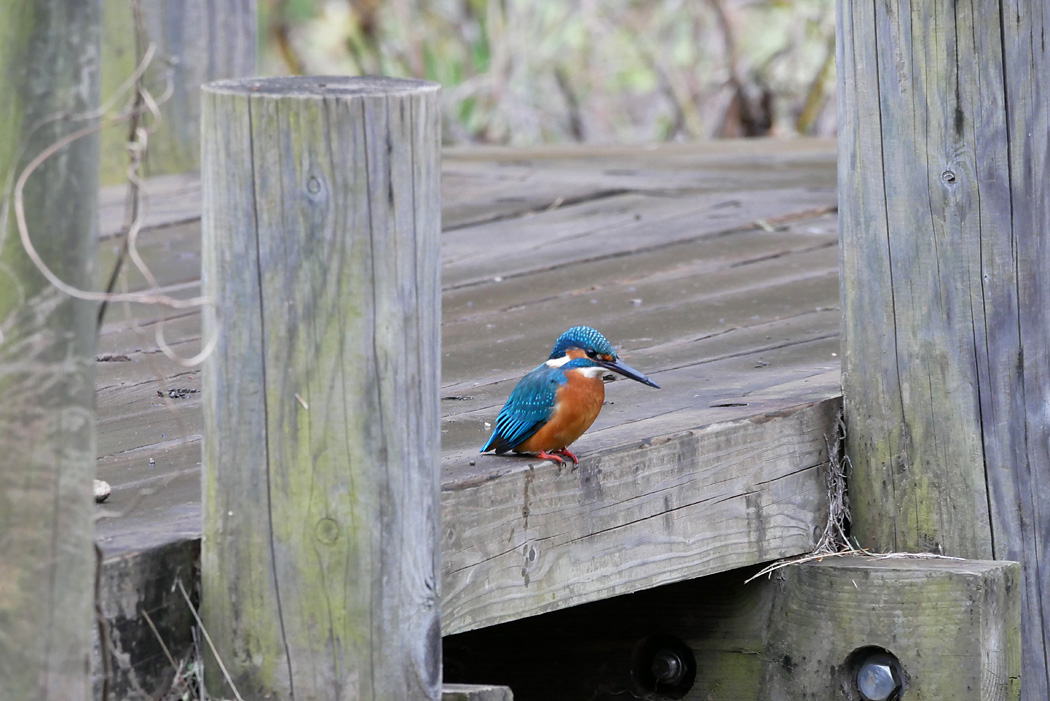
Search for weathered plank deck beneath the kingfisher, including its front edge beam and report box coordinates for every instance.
[98,141,840,688]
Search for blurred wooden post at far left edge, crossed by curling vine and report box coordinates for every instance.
[0,0,99,699]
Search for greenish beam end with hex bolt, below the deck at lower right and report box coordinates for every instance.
[761,557,1021,701]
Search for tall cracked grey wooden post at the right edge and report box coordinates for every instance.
[838,0,1050,700]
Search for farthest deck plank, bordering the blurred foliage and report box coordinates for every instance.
[442,139,835,229]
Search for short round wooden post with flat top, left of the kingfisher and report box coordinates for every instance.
[202,77,441,700]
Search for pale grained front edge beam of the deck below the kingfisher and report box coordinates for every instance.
[442,400,838,634]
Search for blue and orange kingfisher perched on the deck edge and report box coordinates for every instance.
[480,326,659,467]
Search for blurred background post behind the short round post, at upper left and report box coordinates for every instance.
[102,0,258,185]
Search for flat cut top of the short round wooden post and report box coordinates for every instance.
[202,76,441,98]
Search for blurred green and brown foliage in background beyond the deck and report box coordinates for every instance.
[259,0,835,145]
